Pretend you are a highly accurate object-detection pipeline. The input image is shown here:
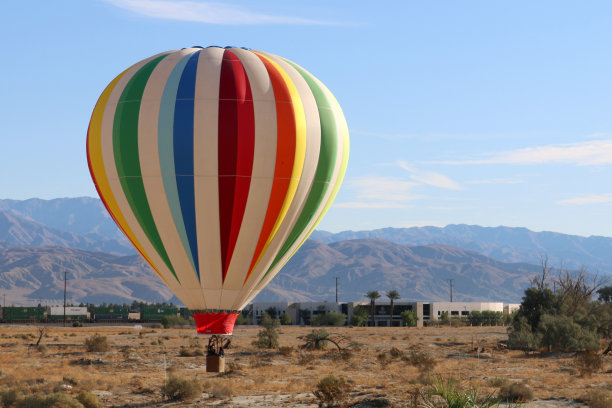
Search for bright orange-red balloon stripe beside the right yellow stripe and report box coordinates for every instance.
[244,55,296,282]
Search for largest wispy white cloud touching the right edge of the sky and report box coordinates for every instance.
[436,139,612,166]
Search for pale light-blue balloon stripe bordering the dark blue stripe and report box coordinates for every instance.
[158,54,198,275]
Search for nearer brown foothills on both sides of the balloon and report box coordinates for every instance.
[0,240,538,304]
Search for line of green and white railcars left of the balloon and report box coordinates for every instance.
[0,306,186,323]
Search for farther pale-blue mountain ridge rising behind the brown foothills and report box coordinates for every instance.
[0,197,612,274]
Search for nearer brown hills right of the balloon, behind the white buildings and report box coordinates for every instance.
[257,239,540,303]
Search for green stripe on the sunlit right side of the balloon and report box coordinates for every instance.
[262,60,340,280]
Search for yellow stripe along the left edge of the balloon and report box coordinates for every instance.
[87,66,167,283]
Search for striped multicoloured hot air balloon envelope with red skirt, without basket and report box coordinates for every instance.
[87,47,349,342]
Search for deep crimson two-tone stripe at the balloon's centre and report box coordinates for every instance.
[218,50,255,281]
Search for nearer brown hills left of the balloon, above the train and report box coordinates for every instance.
[0,247,176,305]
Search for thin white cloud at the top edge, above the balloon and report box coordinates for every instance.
[106,0,331,25]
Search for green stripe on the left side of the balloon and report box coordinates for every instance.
[113,54,178,281]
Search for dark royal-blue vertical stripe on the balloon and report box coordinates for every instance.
[173,51,200,279]
